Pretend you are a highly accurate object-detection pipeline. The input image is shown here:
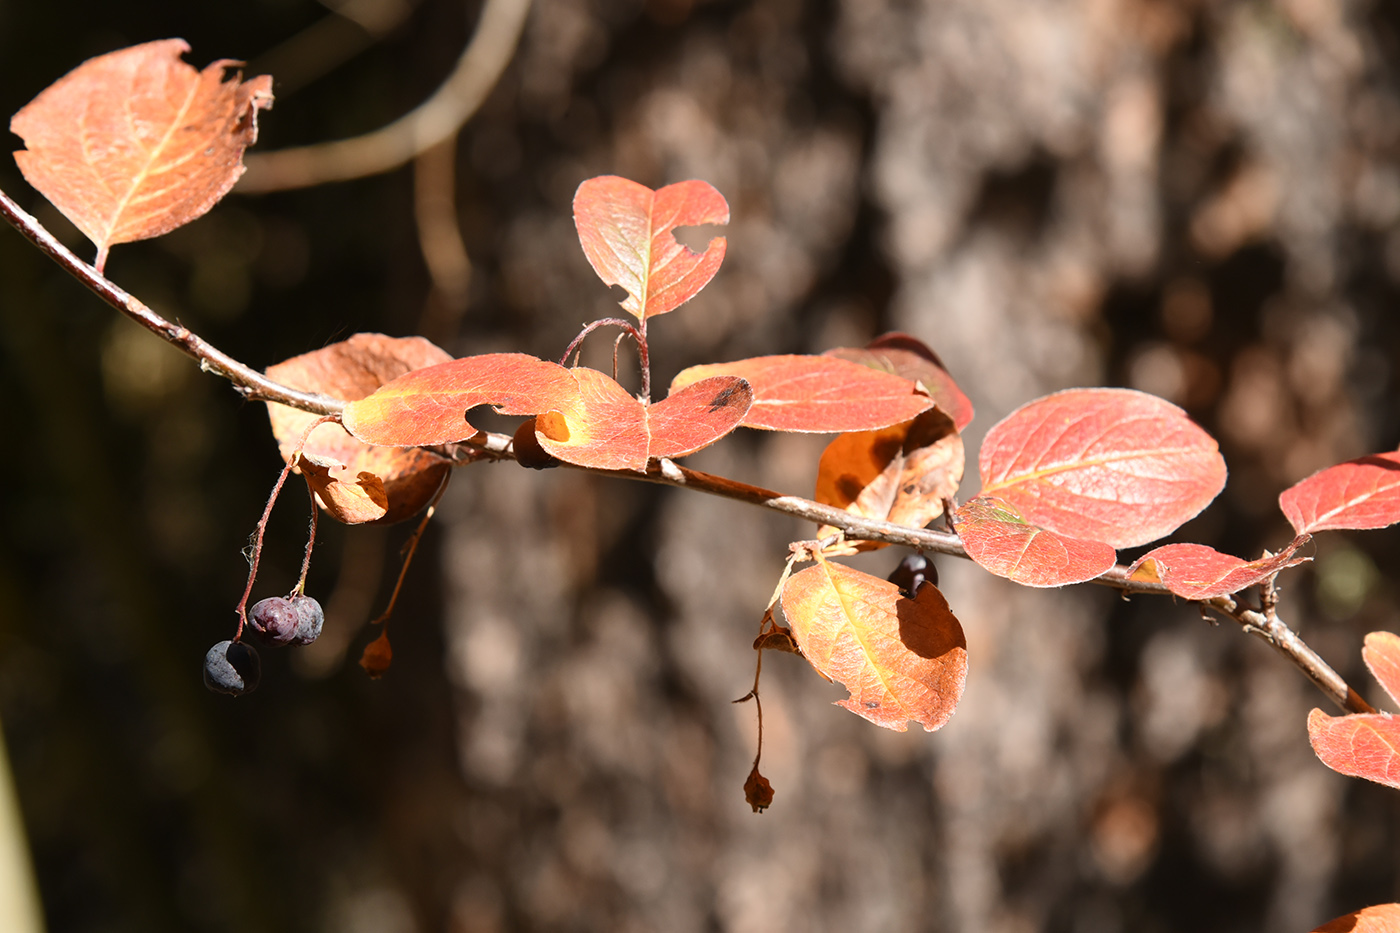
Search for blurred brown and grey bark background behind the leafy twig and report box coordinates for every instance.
[0,0,1400,933]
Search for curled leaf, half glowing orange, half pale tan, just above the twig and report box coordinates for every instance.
[815,409,963,549]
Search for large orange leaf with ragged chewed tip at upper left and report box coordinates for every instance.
[10,39,272,270]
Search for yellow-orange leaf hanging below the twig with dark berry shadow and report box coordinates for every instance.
[783,560,967,731]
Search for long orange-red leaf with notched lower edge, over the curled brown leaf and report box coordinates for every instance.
[340,353,578,447]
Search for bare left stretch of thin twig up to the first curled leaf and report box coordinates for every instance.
[0,191,344,415]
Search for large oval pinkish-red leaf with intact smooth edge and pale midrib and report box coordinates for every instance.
[979,388,1225,548]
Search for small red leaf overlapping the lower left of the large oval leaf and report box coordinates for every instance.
[953,496,1117,587]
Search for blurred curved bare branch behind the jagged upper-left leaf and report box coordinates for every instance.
[237,0,529,193]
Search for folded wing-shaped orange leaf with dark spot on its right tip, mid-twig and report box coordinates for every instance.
[535,367,753,472]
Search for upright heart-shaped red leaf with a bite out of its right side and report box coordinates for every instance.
[574,175,729,319]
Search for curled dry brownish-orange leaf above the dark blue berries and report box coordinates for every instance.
[267,333,451,524]
